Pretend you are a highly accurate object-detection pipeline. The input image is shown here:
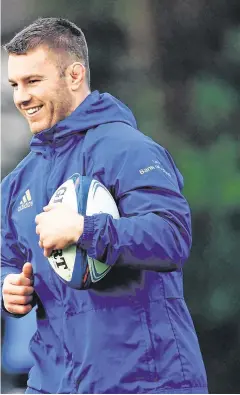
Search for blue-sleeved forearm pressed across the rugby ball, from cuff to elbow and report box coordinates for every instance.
[79,213,191,271]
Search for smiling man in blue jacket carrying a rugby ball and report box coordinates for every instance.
[2,18,207,394]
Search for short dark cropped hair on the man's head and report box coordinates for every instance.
[3,18,90,85]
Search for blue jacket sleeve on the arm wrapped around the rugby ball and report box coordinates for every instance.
[79,132,191,271]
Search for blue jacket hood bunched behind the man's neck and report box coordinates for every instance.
[30,91,137,148]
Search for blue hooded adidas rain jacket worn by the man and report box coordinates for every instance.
[2,91,207,393]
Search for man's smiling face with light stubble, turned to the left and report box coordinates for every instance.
[8,46,76,134]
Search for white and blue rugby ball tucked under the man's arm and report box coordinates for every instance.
[48,173,119,289]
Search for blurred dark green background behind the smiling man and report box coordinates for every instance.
[2,0,240,393]
